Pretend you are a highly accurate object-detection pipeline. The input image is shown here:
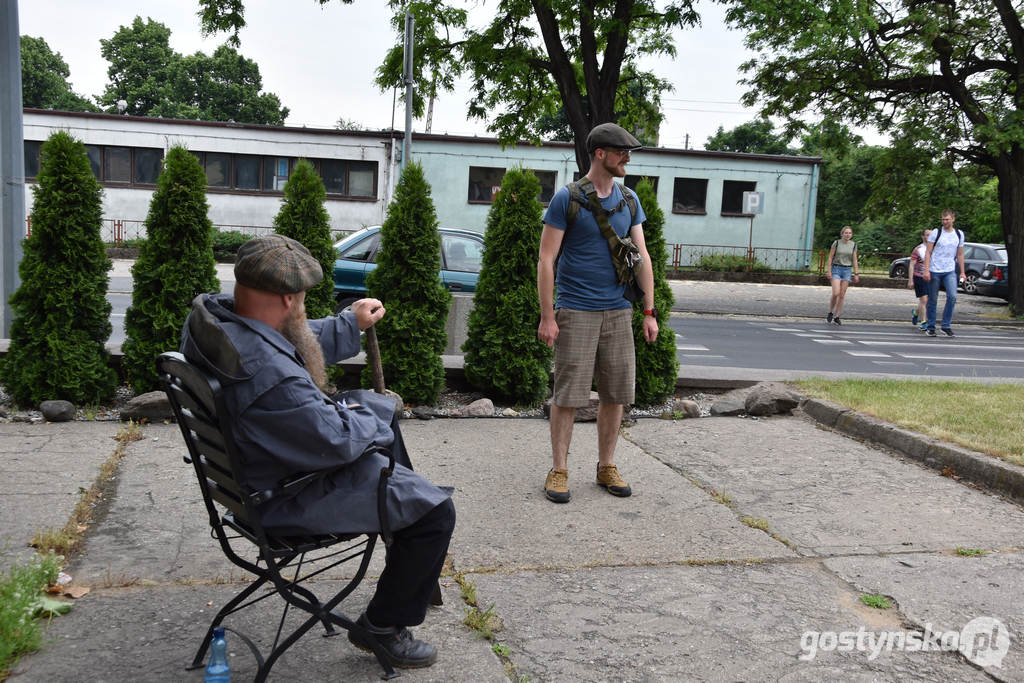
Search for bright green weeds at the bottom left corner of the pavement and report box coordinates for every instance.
[0,554,60,681]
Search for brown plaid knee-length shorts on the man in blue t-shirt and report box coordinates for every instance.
[551,308,636,408]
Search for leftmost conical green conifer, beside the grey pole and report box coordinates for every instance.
[0,132,117,407]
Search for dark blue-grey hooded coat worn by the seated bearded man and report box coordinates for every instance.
[181,294,451,533]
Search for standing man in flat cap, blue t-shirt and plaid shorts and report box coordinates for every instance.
[537,123,657,503]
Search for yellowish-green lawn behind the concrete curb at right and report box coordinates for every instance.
[793,378,1024,466]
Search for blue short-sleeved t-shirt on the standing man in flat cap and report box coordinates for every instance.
[544,182,647,310]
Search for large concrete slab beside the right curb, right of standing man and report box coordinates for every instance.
[629,417,1024,556]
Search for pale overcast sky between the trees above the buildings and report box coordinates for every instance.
[12,0,880,148]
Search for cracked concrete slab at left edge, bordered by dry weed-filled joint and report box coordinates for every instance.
[0,422,121,572]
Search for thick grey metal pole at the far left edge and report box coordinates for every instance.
[0,0,25,339]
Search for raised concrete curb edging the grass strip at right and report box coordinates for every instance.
[801,398,1024,503]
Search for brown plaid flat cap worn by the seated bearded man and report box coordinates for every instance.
[234,234,324,294]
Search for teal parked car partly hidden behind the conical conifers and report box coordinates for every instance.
[334,225,483,310]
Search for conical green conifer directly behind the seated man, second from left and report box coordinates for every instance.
[122,146,220,393]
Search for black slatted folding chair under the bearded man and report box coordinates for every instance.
[157,352,398,682]
